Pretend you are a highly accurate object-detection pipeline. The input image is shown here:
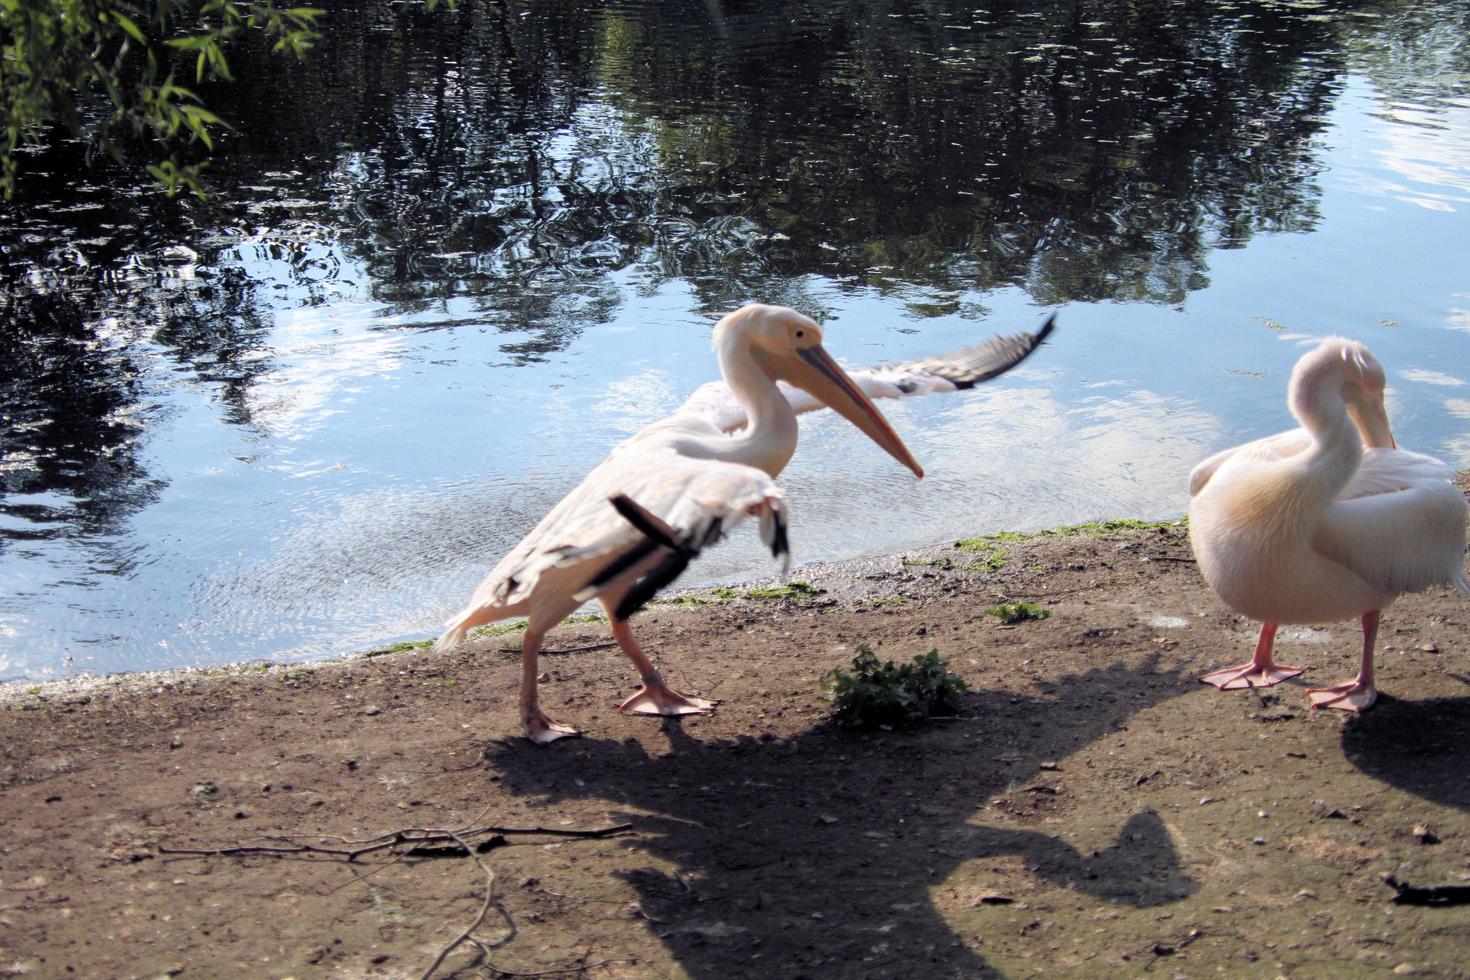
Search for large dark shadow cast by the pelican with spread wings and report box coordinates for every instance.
[485,657,1198,977]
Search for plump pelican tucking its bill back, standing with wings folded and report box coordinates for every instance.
[1189,336,1470,711]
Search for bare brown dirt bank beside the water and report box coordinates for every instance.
[0,511,1470,979]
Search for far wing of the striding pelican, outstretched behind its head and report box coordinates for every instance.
[678,316,1055,432]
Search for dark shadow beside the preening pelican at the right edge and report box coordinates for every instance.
[1342,677,1470,810]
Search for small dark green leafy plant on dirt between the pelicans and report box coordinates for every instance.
[823,644,966,730]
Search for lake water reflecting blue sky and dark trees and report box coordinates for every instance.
[0,0,1470,680]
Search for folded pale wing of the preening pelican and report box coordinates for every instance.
[1313,450,1470,594]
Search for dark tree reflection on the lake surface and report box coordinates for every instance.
[0,0,1470,667]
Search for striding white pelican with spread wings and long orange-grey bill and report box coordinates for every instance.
[434,304,1051,743]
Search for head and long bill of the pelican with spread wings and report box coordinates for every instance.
[714,303,923,478]
